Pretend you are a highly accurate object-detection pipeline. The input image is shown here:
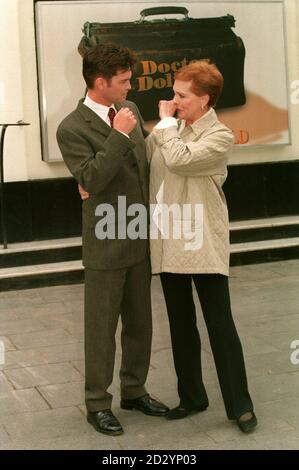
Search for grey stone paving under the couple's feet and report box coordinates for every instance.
[0,260,299,450]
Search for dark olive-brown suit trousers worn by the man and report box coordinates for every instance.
[85,258,152,412]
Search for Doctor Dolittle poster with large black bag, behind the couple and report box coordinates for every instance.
[36,0,290,161]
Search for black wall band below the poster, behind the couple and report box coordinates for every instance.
[0,161,299,243]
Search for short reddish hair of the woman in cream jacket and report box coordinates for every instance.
[174,59,223,107]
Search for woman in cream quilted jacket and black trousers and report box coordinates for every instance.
[147,60,257,432]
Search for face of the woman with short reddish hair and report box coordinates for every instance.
[173,80,209,123]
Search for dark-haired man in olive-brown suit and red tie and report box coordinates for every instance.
[57,44,168,435]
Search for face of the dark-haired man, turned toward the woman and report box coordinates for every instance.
[96,70,132,106]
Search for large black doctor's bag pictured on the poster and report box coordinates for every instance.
[78,6,246,121]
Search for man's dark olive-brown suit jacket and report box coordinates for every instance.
[57,100,148,269]
